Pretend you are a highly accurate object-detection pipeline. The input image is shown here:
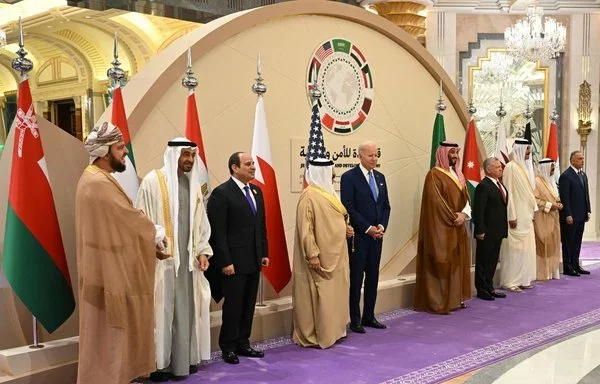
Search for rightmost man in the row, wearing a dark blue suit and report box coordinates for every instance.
[558,151,592,276]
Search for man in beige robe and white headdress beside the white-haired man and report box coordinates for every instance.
[292,159,354,348]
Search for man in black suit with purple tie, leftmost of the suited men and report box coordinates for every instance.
[207,152,269,364]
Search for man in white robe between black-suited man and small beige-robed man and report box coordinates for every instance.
[500,139,538,292]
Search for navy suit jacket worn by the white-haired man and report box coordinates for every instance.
[340,165,390,236]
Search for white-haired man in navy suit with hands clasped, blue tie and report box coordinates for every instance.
[341,142,390,333]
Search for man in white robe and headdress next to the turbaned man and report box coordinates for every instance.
[137,138,213,382]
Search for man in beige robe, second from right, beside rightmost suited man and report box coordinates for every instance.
[533,158,562,280]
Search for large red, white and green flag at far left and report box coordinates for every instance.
[2,75,75,332]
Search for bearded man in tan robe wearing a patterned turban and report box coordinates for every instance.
[75,122,169,384]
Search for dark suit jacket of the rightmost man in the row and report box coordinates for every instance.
[558,167,592,221]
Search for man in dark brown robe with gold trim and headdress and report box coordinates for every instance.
[414,141,471,315]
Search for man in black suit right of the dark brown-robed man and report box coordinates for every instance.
[472,157,509,301]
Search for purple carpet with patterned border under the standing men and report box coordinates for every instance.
[151,243,600,384]
